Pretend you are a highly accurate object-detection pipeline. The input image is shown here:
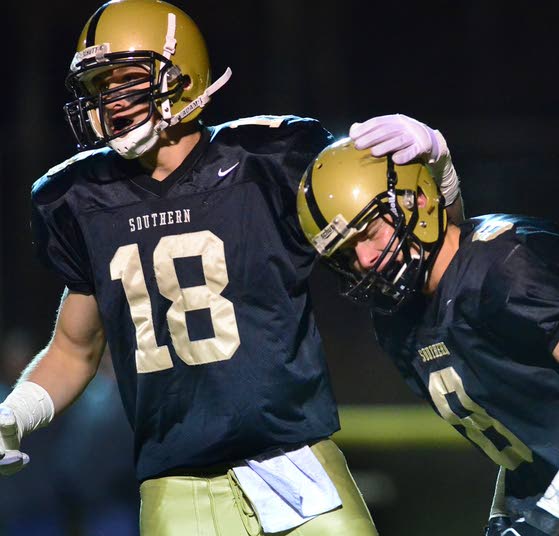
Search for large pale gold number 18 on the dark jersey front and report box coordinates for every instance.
[110,231,240,373]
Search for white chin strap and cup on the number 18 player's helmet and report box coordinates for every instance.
[108,67,232,160]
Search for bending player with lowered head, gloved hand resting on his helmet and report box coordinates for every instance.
[298,139,559,536]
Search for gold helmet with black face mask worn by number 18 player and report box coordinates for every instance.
[64,0,230,158]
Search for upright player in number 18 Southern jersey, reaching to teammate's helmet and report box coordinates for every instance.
[0,0,460,536]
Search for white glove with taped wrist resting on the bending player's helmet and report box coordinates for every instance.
[349,114,460,205]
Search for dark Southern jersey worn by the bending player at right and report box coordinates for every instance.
[375,214,559,512]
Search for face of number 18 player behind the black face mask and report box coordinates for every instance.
[93,65,153,135]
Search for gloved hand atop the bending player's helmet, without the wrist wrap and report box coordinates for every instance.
[349,114,446,165]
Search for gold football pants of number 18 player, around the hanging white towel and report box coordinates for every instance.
[140,440,378,536]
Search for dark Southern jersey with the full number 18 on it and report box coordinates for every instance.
[32,116,339,481]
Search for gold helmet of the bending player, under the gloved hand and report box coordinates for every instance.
[297,138,446,313]
